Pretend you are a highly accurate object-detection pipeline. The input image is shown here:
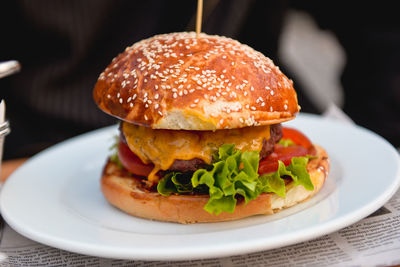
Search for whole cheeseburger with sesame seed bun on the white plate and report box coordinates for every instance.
[93,32,329,224]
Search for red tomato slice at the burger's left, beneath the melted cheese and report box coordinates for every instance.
[118,141,154,176]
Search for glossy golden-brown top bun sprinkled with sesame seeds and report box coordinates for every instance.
[93,32,299,130]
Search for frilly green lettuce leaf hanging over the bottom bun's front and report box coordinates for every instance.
[157,144,314,215]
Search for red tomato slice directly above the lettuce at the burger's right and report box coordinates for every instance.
[258,145,309,174]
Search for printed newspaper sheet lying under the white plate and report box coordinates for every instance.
[0,107,400,267]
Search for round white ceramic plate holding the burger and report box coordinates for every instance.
[0,115,400,260]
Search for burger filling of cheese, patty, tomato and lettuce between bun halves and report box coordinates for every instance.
[111,122,315,214]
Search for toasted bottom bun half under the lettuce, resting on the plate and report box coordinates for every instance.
[101,145,329,224]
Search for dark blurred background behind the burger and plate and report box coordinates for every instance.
[0,0,400,159]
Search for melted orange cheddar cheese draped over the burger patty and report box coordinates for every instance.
[122,122,270,182]
